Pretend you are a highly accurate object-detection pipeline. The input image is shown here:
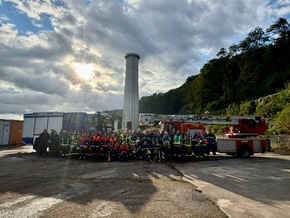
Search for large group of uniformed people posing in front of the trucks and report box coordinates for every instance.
[34,129,216,161]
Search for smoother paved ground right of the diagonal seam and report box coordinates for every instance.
[175,153,290,218]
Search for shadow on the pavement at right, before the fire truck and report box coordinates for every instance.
[177,154,290,205]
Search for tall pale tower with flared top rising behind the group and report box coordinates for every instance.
[122,53,140,129]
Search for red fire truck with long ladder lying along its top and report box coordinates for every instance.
[140,114,270,157]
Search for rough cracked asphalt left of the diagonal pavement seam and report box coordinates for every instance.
[0,146,226,218]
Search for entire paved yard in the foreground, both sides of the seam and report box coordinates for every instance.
[0,146,290,218]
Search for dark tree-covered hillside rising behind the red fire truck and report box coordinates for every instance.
[140,18,290,120]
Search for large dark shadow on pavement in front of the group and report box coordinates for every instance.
[0,148,181,213]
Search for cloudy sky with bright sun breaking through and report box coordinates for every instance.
[0,0,290,119]
